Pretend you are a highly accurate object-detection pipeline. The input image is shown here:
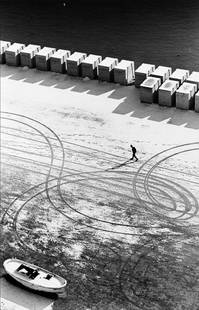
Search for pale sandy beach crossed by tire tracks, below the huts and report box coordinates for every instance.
[0,65,199,310]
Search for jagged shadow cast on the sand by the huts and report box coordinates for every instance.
[0,65,199,129]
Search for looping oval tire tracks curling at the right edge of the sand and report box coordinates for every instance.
[133,142,199,224]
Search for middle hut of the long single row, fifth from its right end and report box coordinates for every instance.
[50,49,71,73]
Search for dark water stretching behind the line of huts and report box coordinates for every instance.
[0,0,199,71]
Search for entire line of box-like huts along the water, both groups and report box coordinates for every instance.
[0,41,199,112]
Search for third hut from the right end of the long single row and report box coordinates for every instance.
[81,54,102,79]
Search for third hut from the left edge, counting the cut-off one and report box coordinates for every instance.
[20,44,41,68]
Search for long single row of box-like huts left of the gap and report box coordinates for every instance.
[0,41,134,85]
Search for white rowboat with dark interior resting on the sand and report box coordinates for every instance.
[3,258,67,296]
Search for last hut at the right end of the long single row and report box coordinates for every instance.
[113,59,135,85]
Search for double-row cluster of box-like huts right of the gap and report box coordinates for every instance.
[135,64,199,112]
